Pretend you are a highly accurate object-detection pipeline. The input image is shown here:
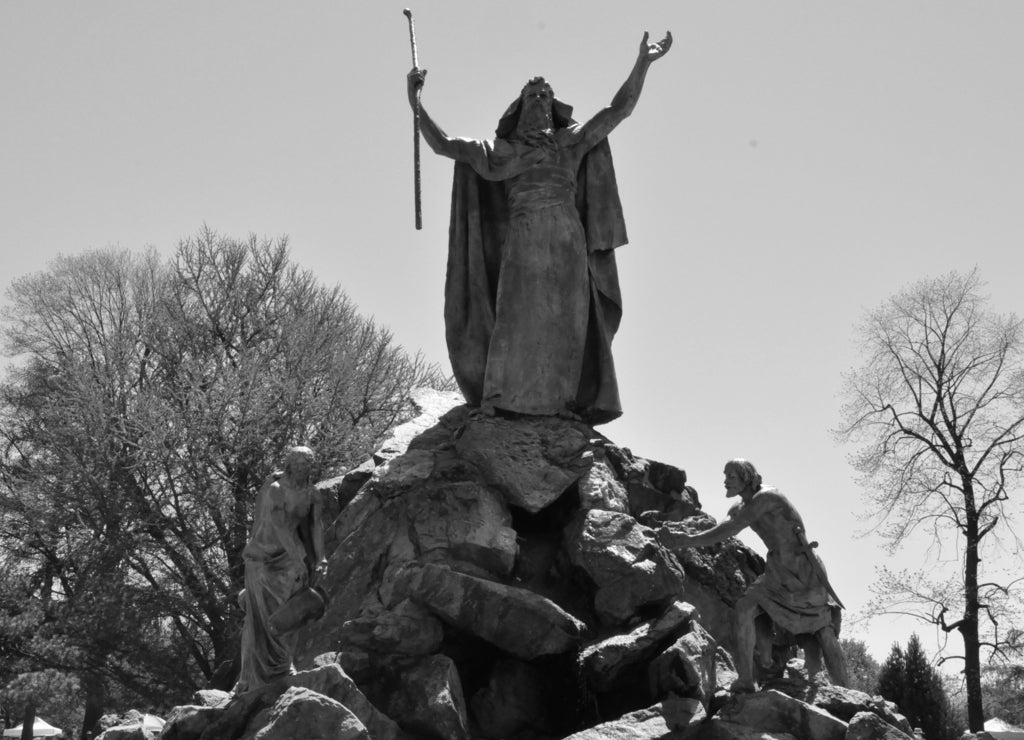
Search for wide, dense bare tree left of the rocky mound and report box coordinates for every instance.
[0,230,447,727]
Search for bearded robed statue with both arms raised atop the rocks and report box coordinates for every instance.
[409,33,672,424]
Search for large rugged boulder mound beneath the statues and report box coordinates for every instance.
[162,391,909,740]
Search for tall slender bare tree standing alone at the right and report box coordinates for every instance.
[837,270,1024,731]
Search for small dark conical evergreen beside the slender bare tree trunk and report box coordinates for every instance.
[878,635,962,740]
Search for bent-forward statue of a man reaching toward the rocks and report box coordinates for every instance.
[658,460,849,692]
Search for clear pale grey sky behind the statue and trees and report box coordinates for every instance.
[0,0,1024,671]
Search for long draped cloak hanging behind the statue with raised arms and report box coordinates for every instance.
[444,101,627,424]
